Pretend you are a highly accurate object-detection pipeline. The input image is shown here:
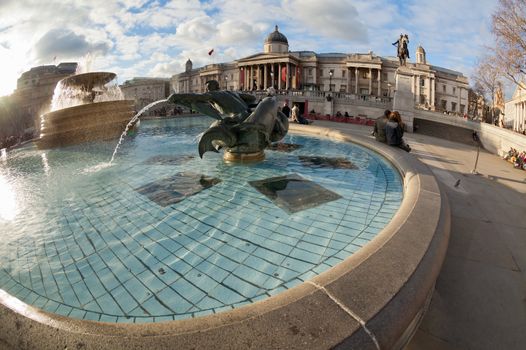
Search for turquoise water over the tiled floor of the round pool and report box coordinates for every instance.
[0,118,403,322]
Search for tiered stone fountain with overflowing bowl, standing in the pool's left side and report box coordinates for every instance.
[37,72,134,149]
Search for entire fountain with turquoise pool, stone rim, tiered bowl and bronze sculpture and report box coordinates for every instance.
[0,83,449,350]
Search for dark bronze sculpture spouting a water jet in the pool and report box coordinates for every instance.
[131,80,289,163]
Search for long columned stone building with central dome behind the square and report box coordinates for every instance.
[171,26,469,114]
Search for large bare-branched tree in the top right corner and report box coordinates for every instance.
[492,0,526,85]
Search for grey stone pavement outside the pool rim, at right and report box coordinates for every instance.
[315,121,526,350]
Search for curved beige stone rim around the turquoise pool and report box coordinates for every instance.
[0,125,450,349]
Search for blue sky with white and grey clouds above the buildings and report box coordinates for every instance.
[0,0,497,96]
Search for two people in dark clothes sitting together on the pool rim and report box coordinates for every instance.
[373,110,411,152]
